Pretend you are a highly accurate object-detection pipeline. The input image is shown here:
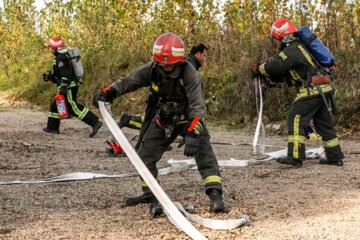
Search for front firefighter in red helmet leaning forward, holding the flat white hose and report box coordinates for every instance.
[94,33,224,212]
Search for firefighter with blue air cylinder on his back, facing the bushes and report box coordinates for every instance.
[252,19,344,167]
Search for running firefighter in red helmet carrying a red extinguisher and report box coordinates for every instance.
[43,37,102,137]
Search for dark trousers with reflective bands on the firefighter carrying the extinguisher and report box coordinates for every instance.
[47,86,99,130]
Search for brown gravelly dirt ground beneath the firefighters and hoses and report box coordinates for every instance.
[0,108,360,240]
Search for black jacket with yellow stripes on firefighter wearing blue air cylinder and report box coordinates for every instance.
[259,40,333,102]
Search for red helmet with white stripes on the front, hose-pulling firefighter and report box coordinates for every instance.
[152,33,185,65]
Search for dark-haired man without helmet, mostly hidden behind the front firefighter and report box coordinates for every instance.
[118,43,209,130]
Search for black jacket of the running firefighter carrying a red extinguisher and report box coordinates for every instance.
[53,48,77,89]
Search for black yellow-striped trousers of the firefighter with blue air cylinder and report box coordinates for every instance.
[287,95,344,161]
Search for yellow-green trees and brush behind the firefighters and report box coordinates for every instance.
[0,0,360,128]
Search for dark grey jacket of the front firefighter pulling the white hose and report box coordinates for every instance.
[111,62,206,120]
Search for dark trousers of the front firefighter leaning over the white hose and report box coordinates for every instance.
[137,119,222,194]
